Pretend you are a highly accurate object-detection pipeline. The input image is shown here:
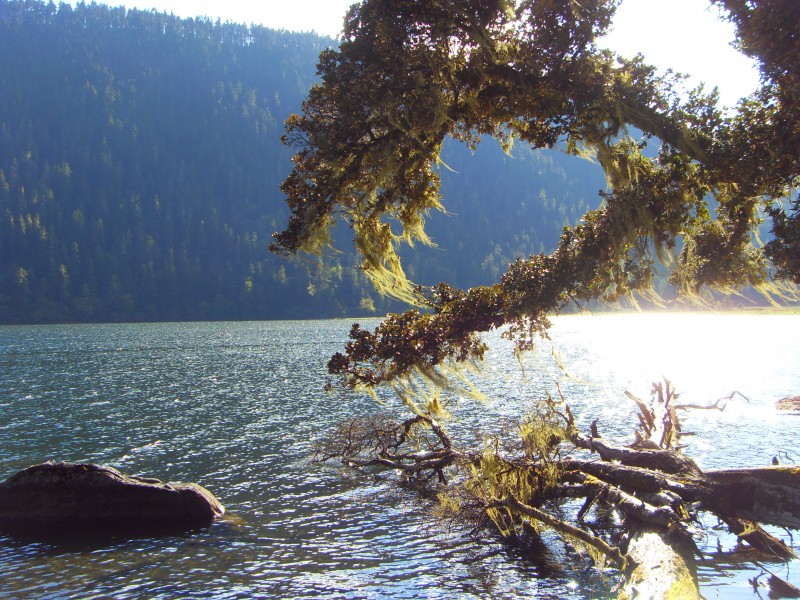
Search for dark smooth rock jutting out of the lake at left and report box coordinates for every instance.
[0,462,225,531]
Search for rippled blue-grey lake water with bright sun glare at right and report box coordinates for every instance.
[0,314,800,598]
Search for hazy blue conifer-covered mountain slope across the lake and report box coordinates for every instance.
[0,0,603,323]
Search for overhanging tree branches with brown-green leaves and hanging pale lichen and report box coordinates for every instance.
[273,0,800,385]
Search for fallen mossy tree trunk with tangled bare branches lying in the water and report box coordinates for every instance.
[317,381,800,598]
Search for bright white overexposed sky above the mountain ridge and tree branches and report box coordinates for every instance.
[72,0,758,106]
